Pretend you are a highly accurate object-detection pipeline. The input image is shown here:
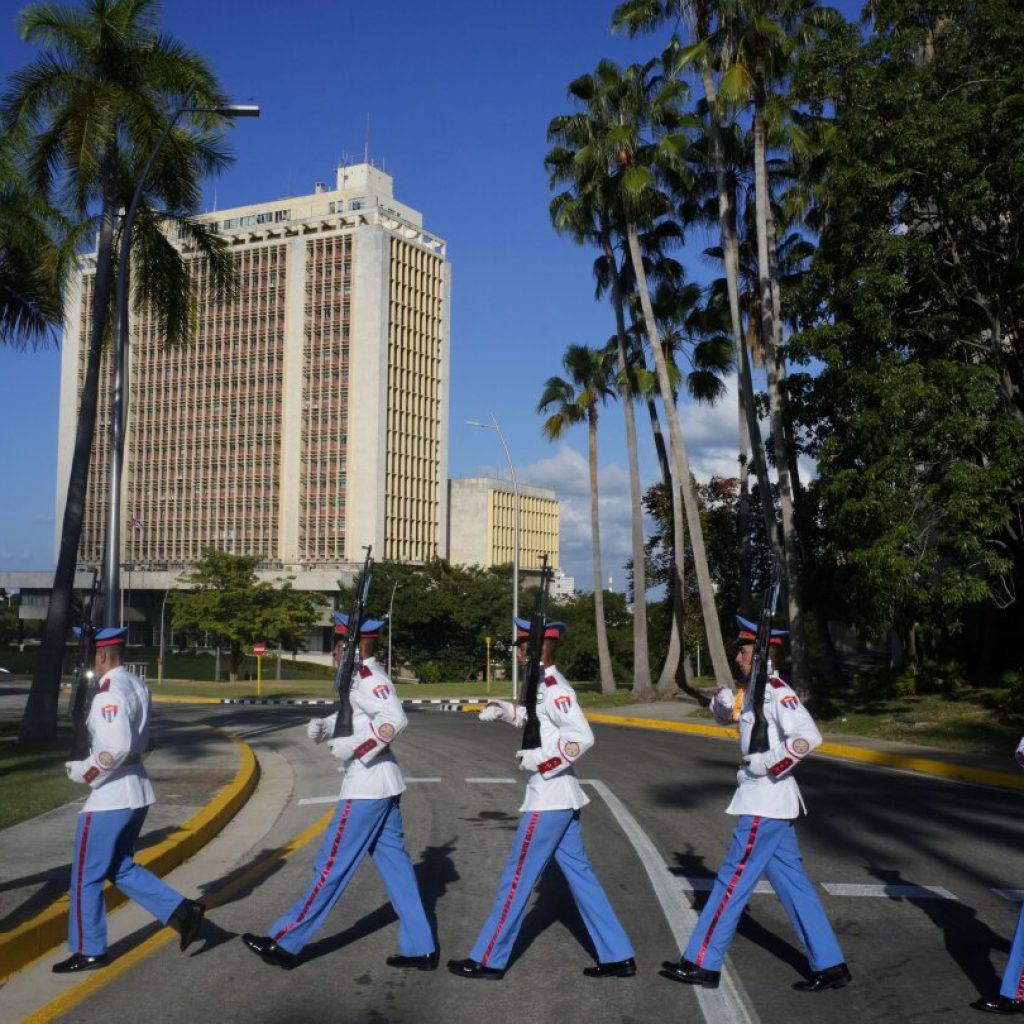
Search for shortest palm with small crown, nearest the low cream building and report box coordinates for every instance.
[537,345,615,693]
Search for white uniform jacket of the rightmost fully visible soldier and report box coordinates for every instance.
[711,675,821,818]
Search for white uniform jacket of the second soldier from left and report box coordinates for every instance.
[325,657,409,800]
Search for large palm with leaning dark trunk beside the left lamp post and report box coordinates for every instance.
[6,0,237,740]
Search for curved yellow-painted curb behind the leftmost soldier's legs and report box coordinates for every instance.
[0,725,259,984]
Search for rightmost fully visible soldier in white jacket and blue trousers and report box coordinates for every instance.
[660,616,852,992]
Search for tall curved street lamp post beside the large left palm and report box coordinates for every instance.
[103,90,259,625]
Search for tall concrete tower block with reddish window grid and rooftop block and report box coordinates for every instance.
[56,164,451,591]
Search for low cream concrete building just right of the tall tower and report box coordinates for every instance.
[447,477,559,571]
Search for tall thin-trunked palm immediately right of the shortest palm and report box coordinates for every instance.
[545,130,651,699]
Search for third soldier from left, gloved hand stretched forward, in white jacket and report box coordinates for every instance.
[447,618,636,980]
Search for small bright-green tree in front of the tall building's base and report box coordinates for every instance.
[171,548,321,680]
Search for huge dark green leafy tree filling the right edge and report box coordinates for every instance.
[792,0,1024,664]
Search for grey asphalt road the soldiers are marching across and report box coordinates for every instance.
[8,707,1024,1024]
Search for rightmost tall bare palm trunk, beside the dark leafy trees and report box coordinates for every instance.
[754,72,807,689]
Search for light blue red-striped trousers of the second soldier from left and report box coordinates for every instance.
[269,797,434,956]
